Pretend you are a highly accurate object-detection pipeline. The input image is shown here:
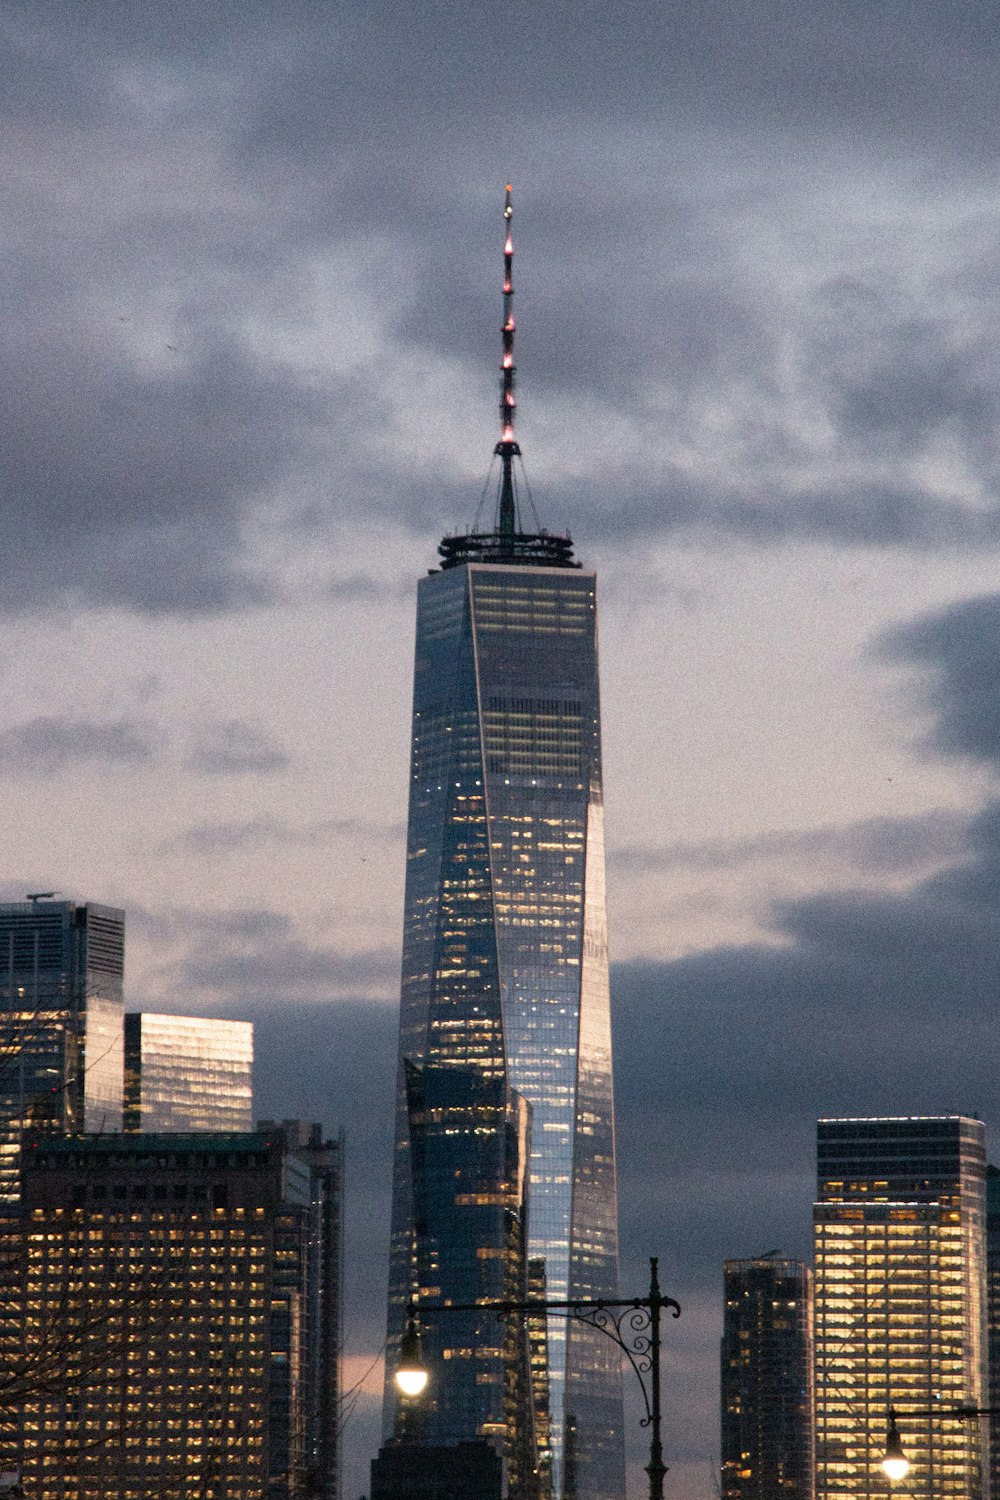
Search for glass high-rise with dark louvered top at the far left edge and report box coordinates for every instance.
[0,896,124,1205]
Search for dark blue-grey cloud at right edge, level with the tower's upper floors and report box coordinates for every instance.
[882,594,1000,770]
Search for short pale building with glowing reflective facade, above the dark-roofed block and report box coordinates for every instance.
[124,1011,253,1131]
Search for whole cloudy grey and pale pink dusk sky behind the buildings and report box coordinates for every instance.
[0,0,1000,1500]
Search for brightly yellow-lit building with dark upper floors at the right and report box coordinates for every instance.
[814,1116,988,1500]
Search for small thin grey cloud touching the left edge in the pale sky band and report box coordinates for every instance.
[0,714,156,776]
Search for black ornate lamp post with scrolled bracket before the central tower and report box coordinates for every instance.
[396,1256,681,1500]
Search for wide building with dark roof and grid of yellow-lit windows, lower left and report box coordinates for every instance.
[0,1130,339,1500]
